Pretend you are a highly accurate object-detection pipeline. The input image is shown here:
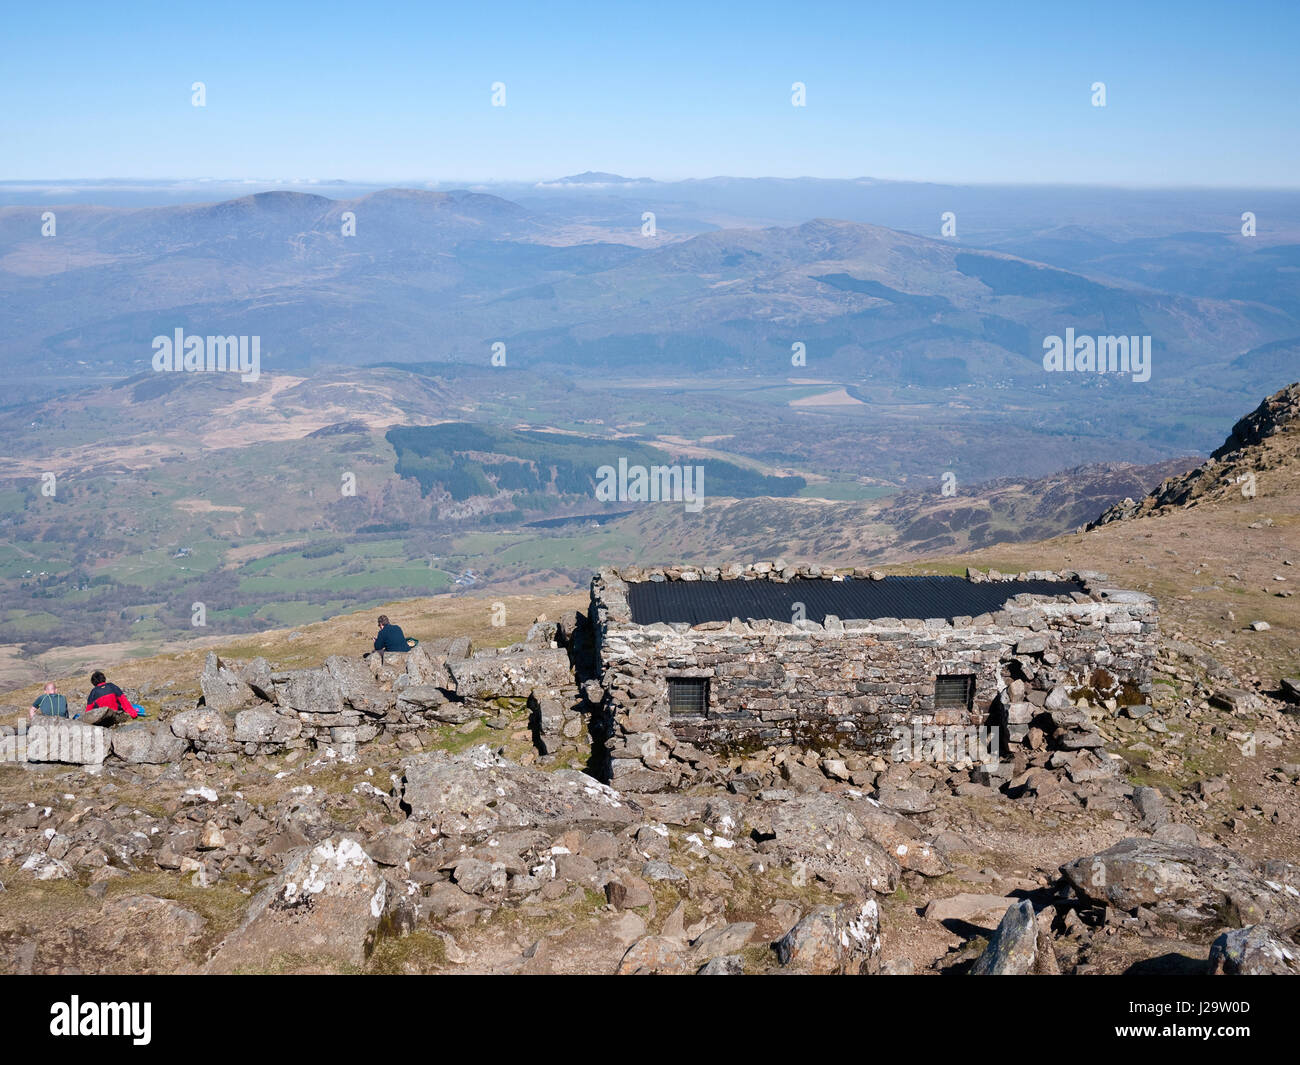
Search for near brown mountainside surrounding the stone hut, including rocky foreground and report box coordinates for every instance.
[0,386,1300,974]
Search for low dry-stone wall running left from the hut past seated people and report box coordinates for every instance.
[0,629,602,765]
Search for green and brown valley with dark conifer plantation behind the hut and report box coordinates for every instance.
[0,362,1206,676]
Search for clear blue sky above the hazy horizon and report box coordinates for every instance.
[0,0,1300,187]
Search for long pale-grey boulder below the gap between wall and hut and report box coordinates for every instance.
[400,745,640,836]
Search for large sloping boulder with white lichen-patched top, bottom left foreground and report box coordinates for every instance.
[205,836,387,973]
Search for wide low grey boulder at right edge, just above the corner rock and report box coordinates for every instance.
[1061,839,1300,932]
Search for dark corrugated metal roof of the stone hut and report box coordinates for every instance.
[628,577,1083,625]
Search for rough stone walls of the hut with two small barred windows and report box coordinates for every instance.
[590,563,1158,789]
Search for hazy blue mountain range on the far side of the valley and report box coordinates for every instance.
[0,190,1300,416]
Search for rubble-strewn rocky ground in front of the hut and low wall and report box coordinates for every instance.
[0,624,1300,974]
